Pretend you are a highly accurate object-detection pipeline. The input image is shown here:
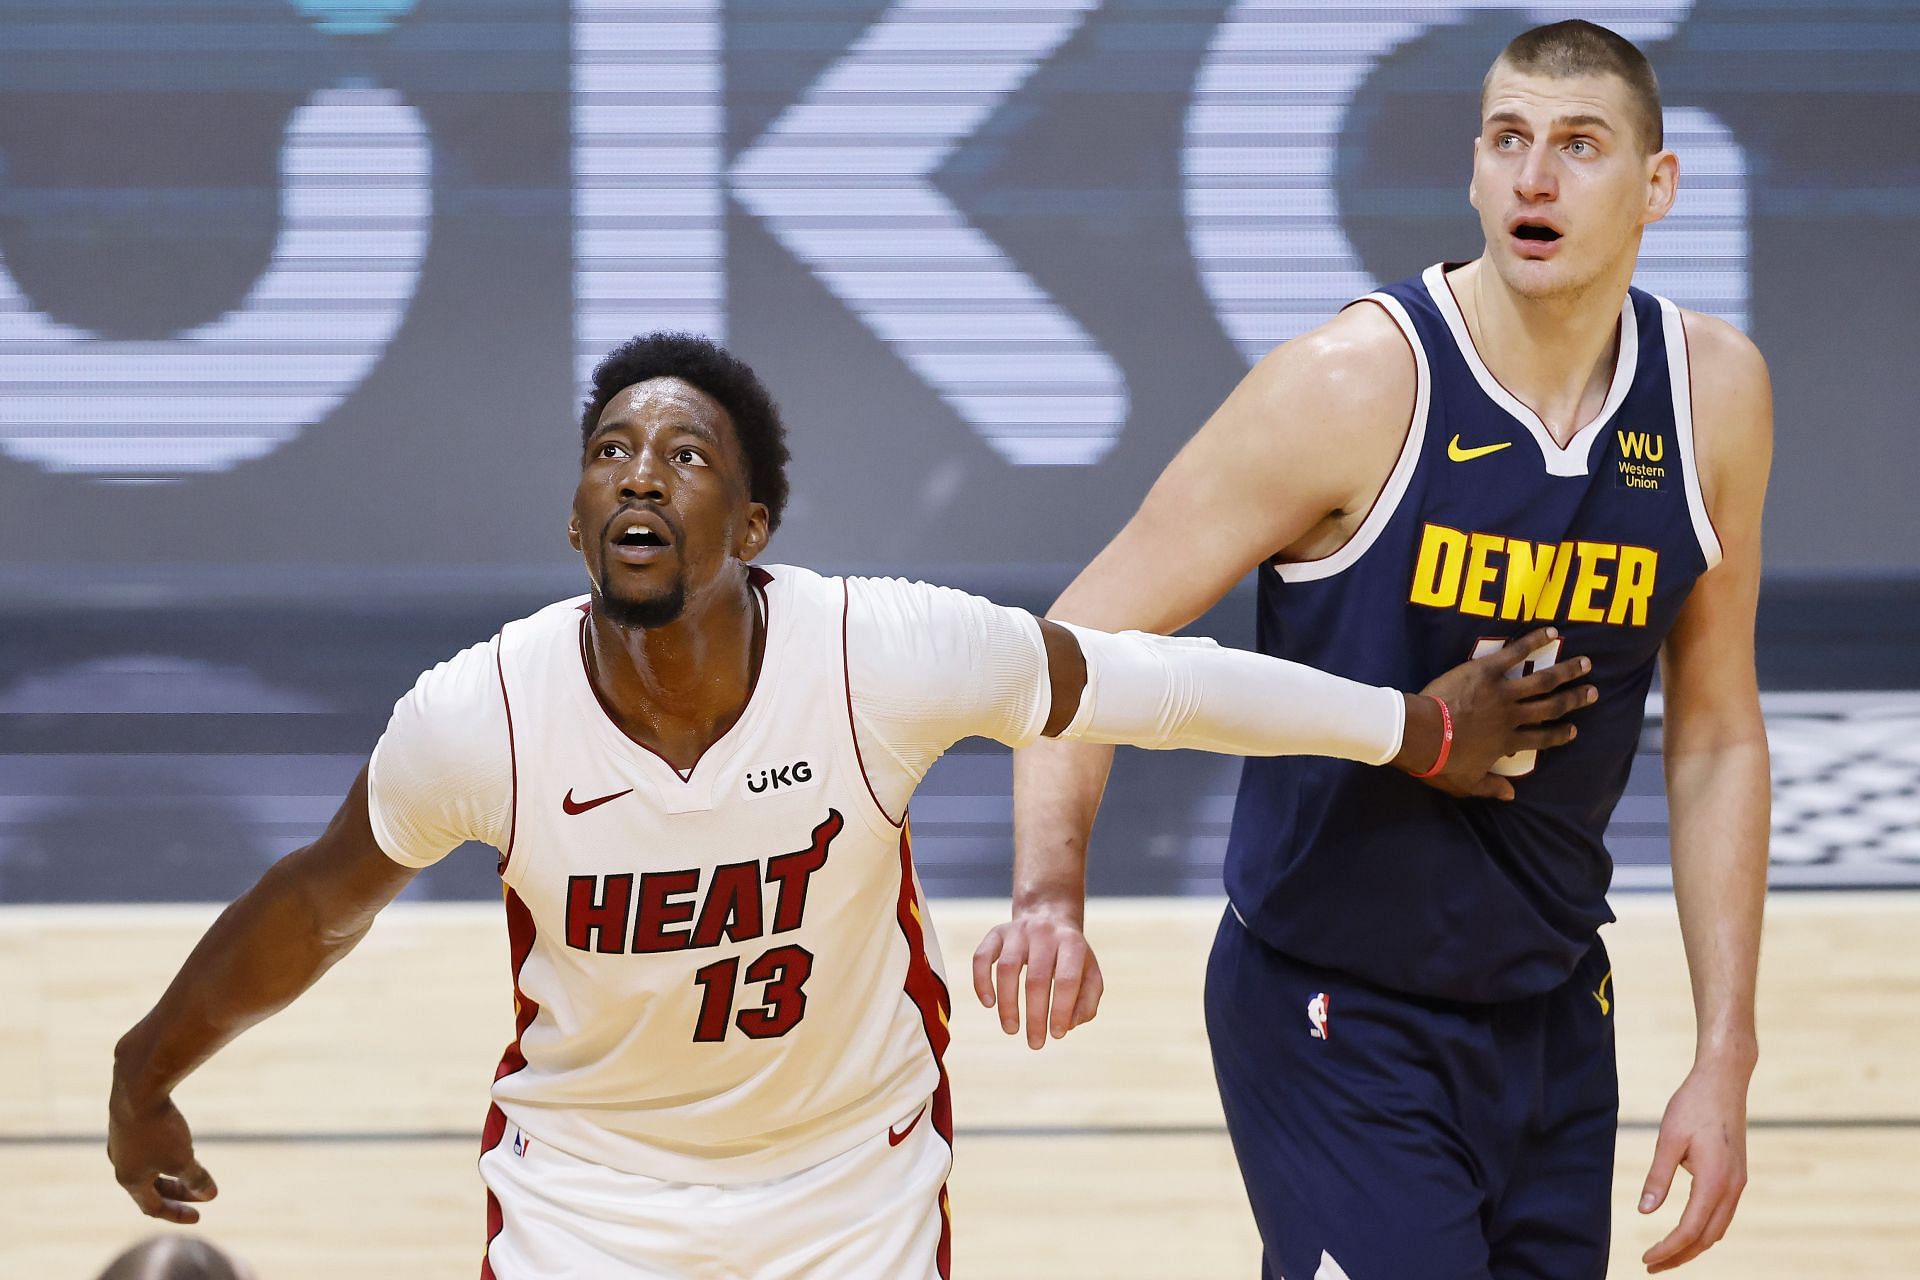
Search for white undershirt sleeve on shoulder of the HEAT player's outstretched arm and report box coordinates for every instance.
[847,578,1052,816]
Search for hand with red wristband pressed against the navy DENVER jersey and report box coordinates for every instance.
[1398,628,1599,800]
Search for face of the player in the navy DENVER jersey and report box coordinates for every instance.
[1469,63,1678,297]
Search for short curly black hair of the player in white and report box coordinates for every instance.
[580,332,791,533]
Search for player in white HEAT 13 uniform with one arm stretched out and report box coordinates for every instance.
[109,334,1592,1280]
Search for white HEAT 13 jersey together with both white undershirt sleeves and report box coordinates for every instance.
[369,566,1046,1184]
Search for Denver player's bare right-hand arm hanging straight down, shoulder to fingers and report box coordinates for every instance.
[1640,315,1772,1270]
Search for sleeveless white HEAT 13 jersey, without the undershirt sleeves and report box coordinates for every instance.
[493,570,950,1182]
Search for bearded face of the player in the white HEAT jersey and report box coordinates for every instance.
[566,378,766,628]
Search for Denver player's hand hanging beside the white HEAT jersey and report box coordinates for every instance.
[973,908,1106,1050]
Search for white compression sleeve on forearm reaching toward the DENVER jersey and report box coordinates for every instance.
[1060,624,1407,764]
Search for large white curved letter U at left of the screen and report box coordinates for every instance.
[0,88,432,482]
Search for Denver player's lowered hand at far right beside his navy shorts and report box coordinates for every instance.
[1640,1061,1749,1272]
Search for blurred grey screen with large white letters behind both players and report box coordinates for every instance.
[0,0,1920,902]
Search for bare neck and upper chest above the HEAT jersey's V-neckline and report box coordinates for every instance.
[588,566,766,771]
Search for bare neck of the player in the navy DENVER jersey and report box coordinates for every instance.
[1452,257,1632,445]
